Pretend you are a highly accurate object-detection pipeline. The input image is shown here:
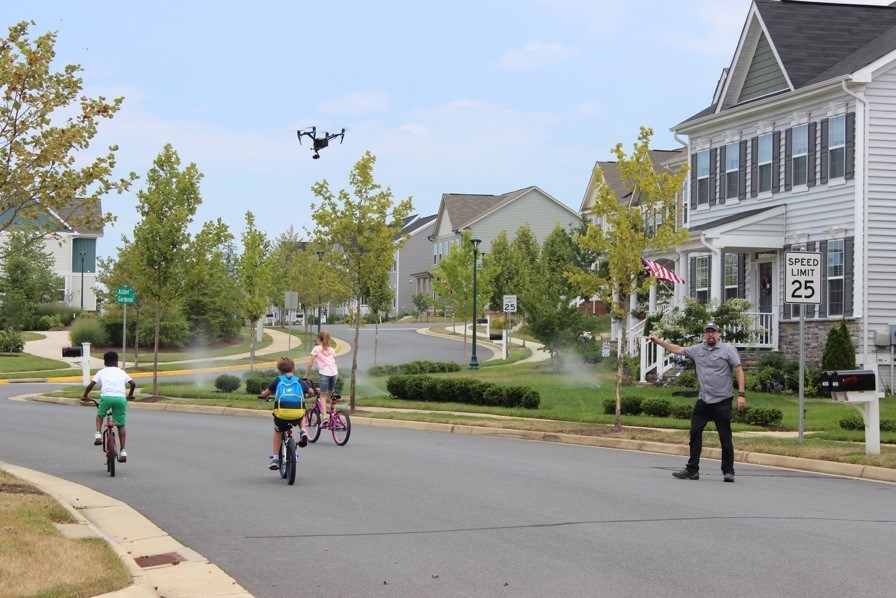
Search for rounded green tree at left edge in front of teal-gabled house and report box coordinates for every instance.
[0,231,65,331]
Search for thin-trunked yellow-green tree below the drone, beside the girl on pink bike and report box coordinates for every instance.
[311,151,413,409]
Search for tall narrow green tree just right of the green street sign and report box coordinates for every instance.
[133,144,202,395]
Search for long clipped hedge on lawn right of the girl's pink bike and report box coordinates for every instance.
[386,375,541,409]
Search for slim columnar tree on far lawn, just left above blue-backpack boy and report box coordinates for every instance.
[239,212,271,370]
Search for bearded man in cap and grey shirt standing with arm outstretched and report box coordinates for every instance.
[647,322,746,482]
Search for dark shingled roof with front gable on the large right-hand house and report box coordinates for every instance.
[676,0,896,128]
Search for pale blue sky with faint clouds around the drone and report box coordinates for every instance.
[8,0,885,256]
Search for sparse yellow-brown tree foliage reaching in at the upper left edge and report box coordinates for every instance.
[0,21,135,260]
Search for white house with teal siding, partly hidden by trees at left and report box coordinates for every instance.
[0,201,103,311]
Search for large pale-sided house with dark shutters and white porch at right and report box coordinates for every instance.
[660,0,896,365]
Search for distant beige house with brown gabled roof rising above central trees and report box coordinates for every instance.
[426,186,580,310]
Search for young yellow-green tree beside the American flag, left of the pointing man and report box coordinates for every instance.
[570,127,688,426]
